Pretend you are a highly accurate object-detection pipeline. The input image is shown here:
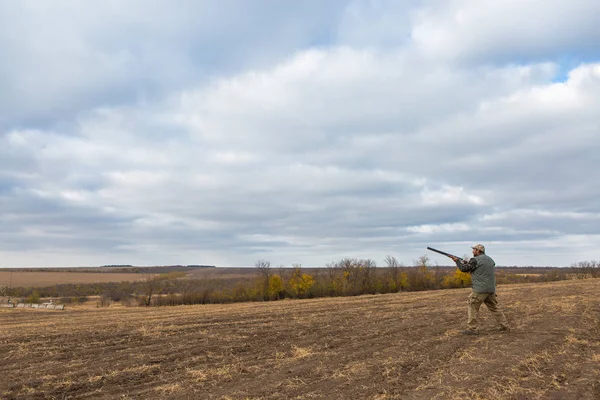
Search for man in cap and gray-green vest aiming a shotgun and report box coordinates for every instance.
[451,244,509,335]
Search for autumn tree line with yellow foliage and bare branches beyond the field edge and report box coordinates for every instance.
[4,256,600,306]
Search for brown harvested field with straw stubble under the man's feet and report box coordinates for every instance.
[0,279,600,400]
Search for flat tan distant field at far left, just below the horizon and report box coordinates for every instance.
[0,270,144,287]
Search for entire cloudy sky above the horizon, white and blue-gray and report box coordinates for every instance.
[0,0,600,266]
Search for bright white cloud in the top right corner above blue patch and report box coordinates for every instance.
[411,0,600,63]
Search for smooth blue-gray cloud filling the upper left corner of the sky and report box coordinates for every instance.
[0,0,342,127]
